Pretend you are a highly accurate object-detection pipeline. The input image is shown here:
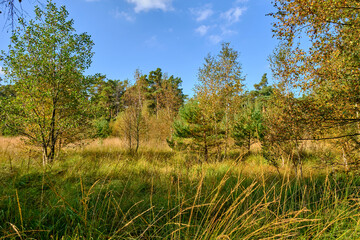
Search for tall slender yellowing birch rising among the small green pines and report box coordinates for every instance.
[195,43,245,158]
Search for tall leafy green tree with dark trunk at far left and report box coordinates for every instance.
[1,1,94,164]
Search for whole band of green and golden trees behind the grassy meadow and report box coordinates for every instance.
[0,0,360,174]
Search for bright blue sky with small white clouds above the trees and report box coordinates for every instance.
[0,0,277,96]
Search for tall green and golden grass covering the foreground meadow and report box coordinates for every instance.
[0,141,360,239]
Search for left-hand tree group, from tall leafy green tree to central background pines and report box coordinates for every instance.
[0,1,185,165]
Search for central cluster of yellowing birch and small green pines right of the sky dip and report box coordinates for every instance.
[168,43,272,161]
